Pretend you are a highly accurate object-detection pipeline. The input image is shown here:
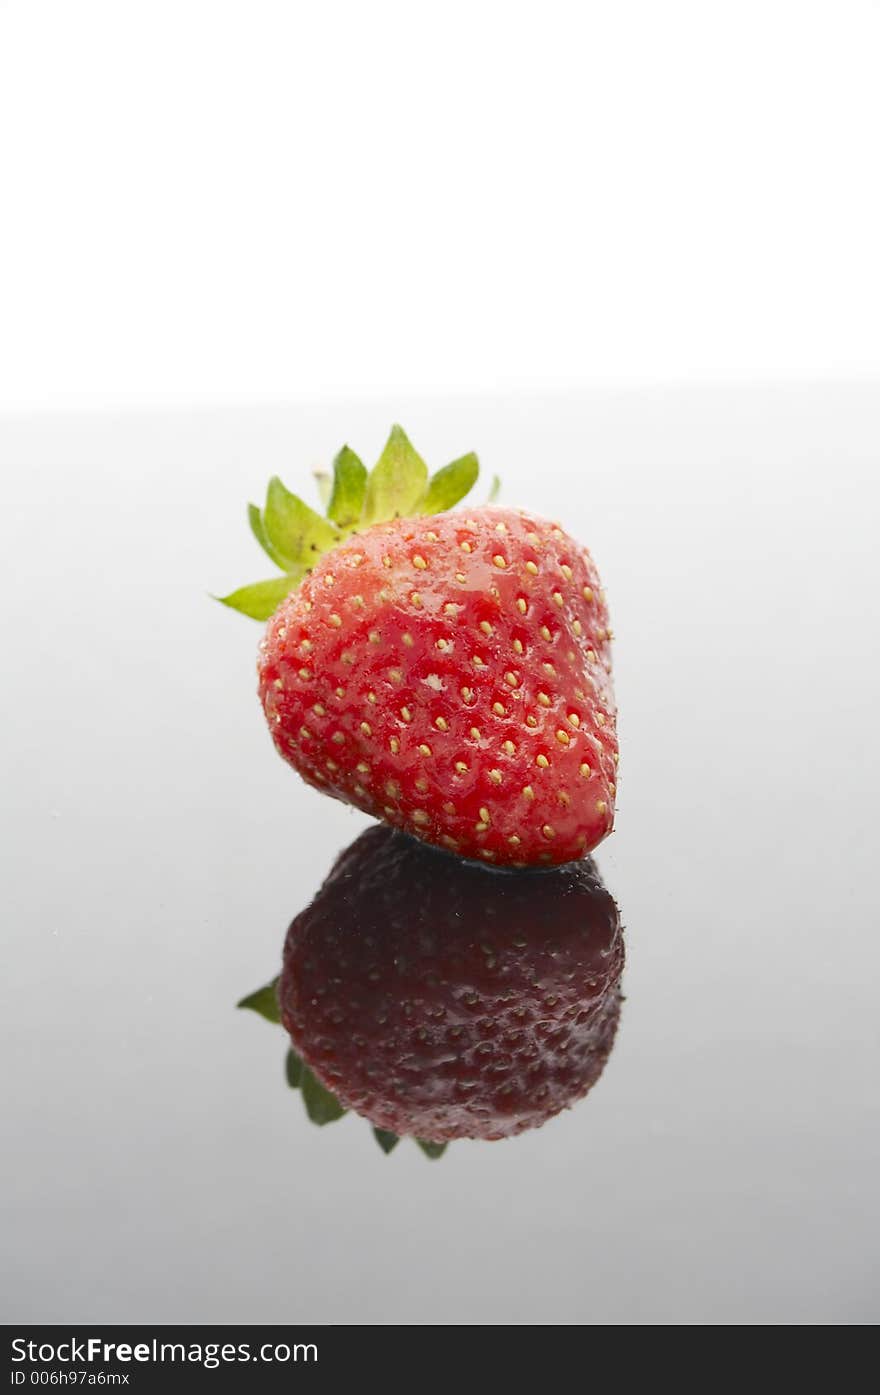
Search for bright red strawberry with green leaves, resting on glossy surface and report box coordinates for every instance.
[220,427,618,866]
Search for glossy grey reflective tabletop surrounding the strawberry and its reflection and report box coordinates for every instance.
[0,384,880,1324]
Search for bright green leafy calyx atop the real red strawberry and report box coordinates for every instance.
[216,425,480,619]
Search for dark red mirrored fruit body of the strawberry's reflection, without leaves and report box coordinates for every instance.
[279,827,623,1143]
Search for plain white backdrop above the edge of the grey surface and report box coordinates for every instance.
[0,0,880,409]
